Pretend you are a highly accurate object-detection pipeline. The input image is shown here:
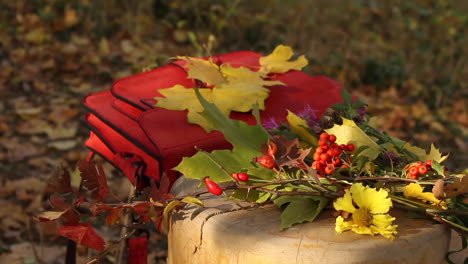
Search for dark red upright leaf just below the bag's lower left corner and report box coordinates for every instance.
[77,160,110,202]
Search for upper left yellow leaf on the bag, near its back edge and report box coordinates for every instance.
[177,56,226,86]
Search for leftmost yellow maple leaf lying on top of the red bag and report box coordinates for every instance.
[155,84,212,131]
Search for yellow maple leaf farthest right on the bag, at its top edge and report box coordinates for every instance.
[260,45,309,74]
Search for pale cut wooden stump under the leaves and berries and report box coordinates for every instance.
[168,197,450,264]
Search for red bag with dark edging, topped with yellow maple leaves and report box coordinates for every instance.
[84,51,341,188]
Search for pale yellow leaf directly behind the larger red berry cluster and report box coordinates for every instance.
[325,118,381,160]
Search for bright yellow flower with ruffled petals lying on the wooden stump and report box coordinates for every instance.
[333,183,398,239]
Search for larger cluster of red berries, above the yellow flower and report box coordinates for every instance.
[312,132,355,174]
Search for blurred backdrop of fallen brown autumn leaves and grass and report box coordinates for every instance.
[0,0,468,263]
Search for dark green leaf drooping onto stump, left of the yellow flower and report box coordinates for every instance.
[274,195,329,229]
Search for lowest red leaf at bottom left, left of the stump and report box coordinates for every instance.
[57,224,104,251]
